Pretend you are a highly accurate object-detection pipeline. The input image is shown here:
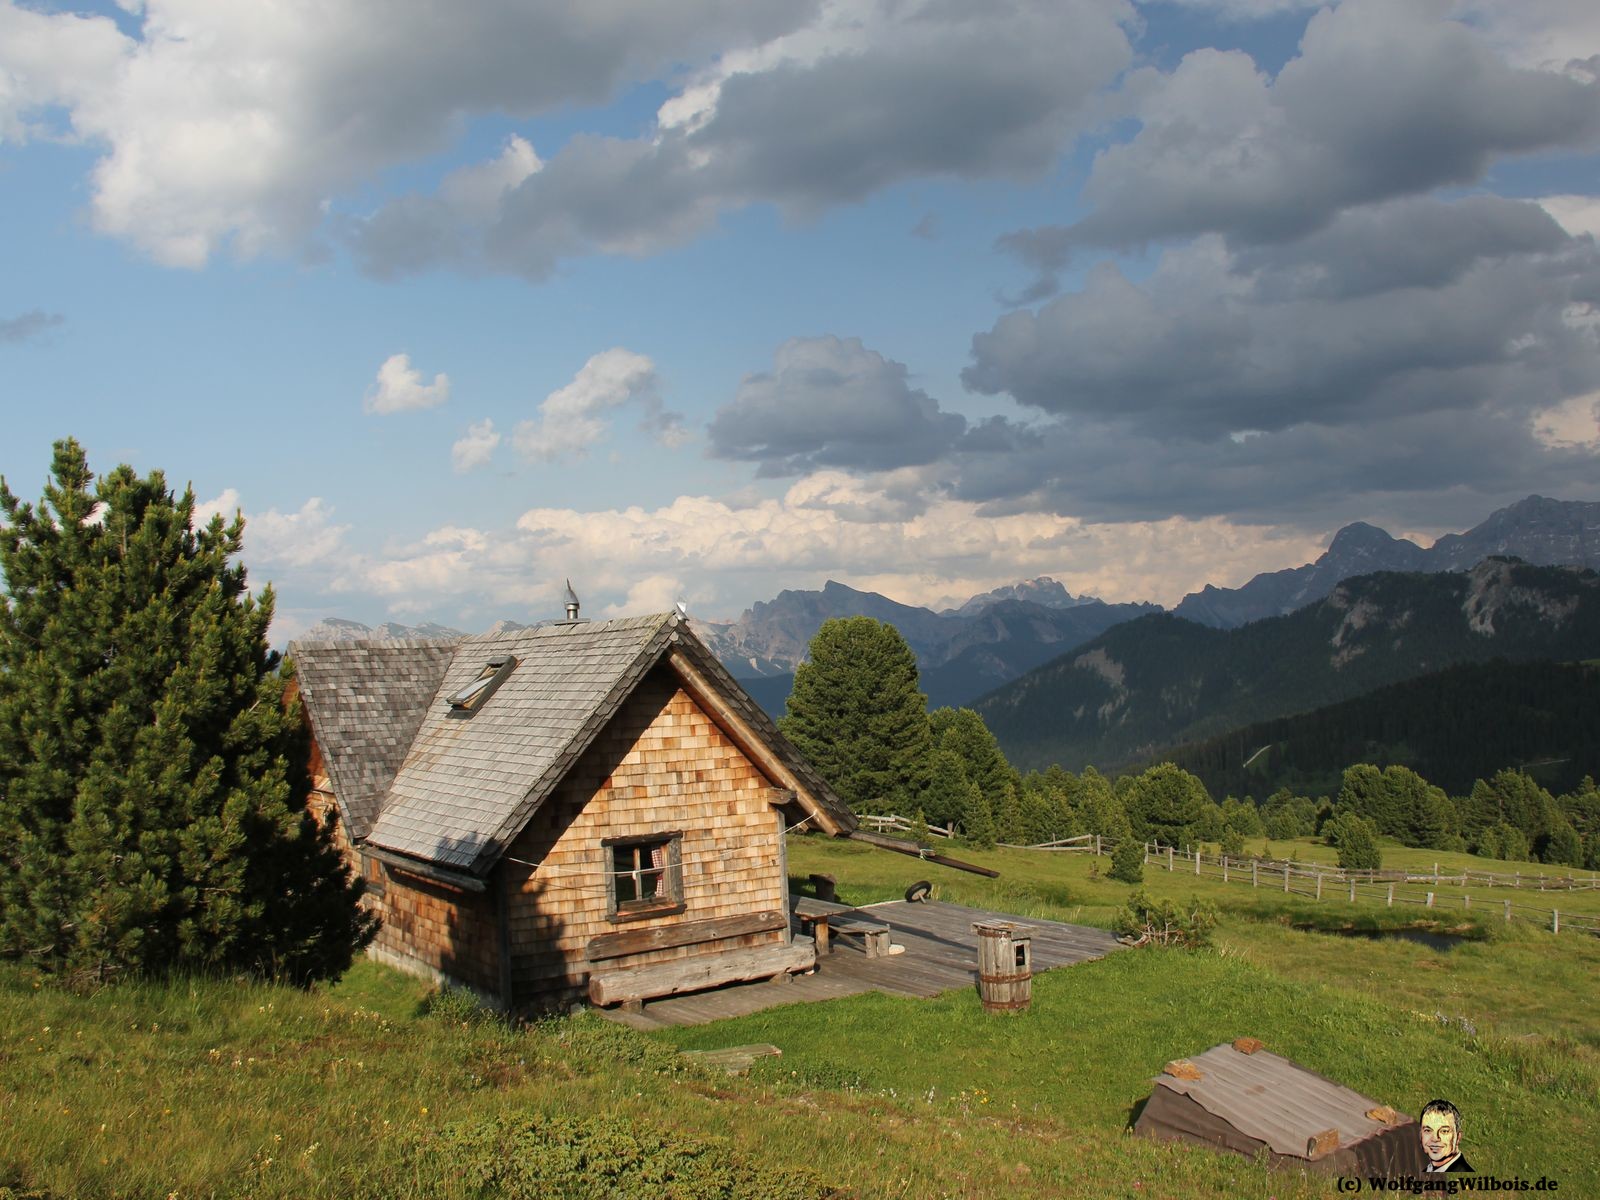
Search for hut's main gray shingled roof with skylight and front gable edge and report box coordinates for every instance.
[296,613,854,875]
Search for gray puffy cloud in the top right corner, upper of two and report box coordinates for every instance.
[1002,0,1600,274]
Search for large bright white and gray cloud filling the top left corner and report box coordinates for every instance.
[0,0,806,267]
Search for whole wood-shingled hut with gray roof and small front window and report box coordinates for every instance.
[290,613,854,1010]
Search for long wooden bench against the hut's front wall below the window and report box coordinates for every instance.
[587,912,816,1008]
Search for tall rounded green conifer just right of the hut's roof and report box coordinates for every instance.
[778,616,946,821]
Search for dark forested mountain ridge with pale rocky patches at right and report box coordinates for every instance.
[973,558,1600,770]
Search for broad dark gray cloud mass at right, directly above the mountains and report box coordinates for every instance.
[963,198,1600,440]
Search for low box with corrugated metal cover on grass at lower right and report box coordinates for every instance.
[1134,1045,1424,1174]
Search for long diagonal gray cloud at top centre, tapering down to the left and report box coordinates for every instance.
[344,0,1131,278]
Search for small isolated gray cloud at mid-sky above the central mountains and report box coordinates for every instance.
[710,338,982,475]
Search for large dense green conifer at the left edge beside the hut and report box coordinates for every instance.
[0,440,374,981]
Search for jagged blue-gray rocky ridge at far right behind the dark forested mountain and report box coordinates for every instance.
[1173,496,1600,629]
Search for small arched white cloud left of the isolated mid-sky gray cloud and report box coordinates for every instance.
[512,346,686,462]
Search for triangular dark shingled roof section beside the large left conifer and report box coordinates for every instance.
[290,638,459,838]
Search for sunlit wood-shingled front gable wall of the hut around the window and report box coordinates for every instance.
[504,666,789,1006]
